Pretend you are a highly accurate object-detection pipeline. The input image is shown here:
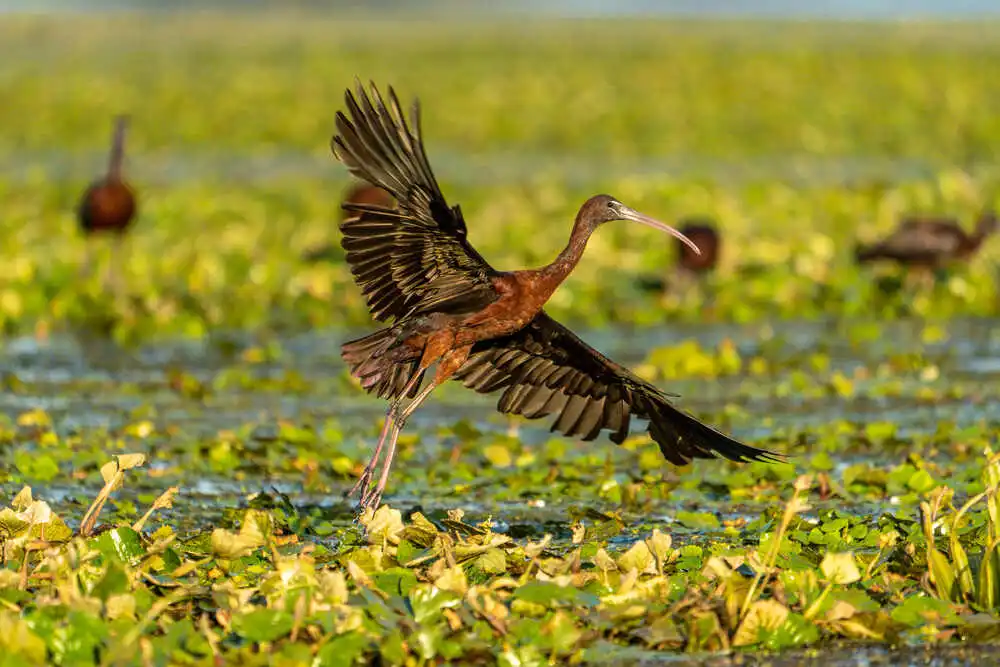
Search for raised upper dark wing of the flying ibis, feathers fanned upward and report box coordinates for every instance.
[331,84,497,320]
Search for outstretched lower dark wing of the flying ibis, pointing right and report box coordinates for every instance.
[455,311,781,465]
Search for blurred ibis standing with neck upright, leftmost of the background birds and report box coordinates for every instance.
[77,116,136,288]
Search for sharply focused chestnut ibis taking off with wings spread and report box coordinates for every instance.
[331,82,780,509]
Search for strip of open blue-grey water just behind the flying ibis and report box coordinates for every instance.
[0,319,1000,428]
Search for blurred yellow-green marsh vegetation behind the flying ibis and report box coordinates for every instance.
[0,11,1000,340]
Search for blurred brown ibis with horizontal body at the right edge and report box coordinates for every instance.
[855,211,998,269]
